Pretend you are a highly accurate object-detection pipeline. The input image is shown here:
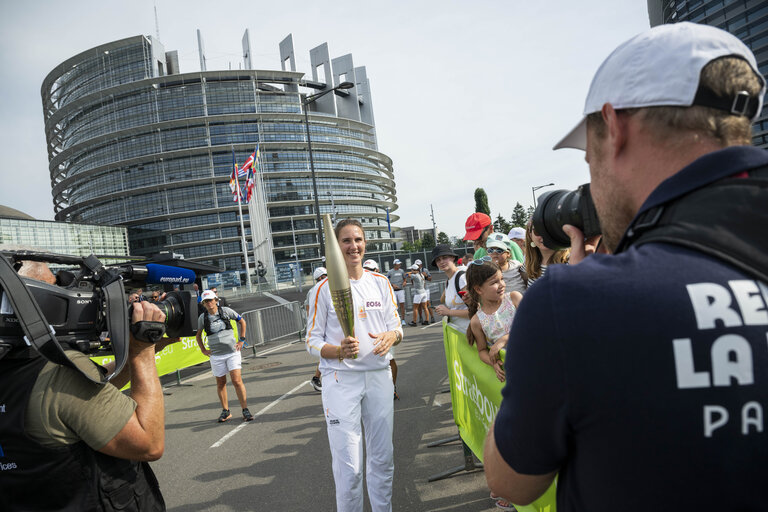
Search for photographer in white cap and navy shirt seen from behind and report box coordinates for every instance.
[483,23,768,512]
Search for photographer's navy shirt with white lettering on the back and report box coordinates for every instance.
[494,146,768,512]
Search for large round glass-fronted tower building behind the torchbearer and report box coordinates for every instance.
[41,30,398,280]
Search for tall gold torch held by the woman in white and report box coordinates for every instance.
[323,213,357,358]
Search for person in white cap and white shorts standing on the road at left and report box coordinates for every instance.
[195,290,253,423]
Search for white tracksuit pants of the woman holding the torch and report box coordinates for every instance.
[323,366,395,512]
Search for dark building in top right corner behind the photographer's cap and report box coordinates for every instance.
[648,0,768,148]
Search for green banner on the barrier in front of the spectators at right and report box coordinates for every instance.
[443,322,557,512]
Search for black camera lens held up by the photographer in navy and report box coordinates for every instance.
[533,183,602,250]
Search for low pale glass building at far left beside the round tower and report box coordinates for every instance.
[0,206,128,262]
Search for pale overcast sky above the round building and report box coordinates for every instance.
[0,0,649,237]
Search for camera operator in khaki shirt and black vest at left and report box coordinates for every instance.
[0,262,178,511]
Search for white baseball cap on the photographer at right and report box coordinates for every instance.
[553,22,765,150]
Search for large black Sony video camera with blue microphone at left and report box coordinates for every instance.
[0,251,197,382]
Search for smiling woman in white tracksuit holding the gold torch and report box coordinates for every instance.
[306,219,403,512]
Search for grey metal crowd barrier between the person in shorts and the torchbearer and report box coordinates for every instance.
[242,302,306,347]
